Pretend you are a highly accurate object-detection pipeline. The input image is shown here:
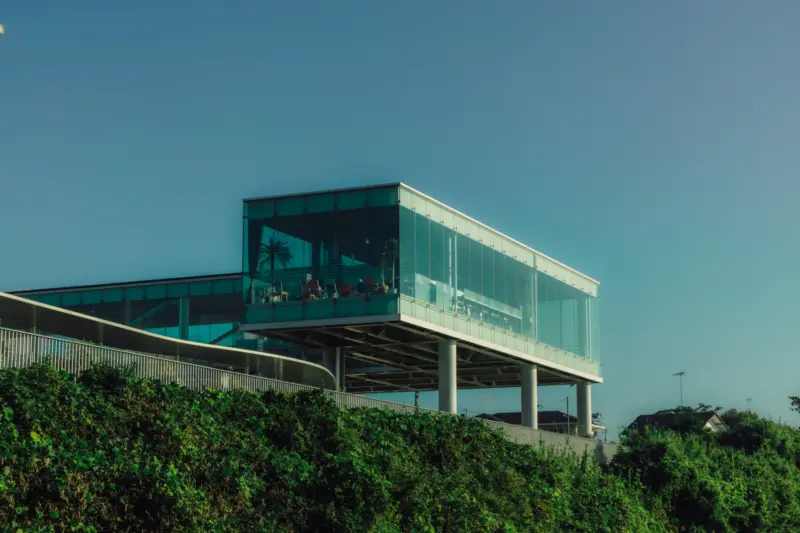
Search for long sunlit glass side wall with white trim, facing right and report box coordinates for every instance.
[399,186,599,371]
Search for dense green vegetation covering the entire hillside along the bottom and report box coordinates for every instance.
[0,364,800,533]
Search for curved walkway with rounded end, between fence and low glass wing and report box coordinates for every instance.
[0,292,336,389]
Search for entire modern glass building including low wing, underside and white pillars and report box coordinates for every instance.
[10,183,602,434]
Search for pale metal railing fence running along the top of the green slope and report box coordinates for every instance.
[0,327,616,462]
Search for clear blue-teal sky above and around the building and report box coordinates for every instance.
[0,0,800,436]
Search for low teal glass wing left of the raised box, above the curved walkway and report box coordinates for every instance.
[22,275,243,346]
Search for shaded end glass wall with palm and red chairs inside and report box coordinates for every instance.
[243,187,400,323]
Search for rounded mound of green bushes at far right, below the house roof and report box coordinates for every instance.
[610,411,800,533]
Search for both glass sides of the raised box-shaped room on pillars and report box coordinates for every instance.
[242,185,600,373]
